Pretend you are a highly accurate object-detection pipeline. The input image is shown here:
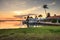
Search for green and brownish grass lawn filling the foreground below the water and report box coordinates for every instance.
[0,26,60,40]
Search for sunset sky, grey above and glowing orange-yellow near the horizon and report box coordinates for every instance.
[0,0,60,19]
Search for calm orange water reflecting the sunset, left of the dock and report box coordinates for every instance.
[0,21,27,29]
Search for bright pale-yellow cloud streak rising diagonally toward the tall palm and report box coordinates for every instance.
[13,6,41,15]
